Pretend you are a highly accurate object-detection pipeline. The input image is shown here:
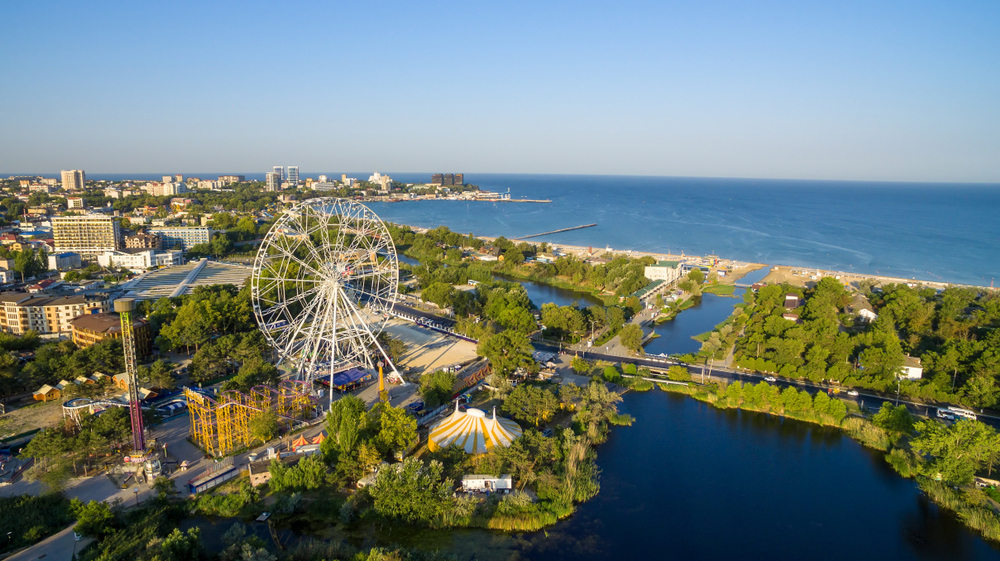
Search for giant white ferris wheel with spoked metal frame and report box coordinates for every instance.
[250,197,399,386]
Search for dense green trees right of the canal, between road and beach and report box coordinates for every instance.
[736,277,1000,407]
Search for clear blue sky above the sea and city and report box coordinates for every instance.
[0,0,1000,182]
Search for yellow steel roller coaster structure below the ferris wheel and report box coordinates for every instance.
[184,380,316,456]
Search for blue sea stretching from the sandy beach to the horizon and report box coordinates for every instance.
[80,172,1000,286]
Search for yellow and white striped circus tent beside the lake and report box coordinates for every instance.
[427,403,521,454]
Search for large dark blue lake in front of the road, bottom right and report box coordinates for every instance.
[504,390,1000,561]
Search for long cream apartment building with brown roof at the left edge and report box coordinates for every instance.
[0,292,108,335]
